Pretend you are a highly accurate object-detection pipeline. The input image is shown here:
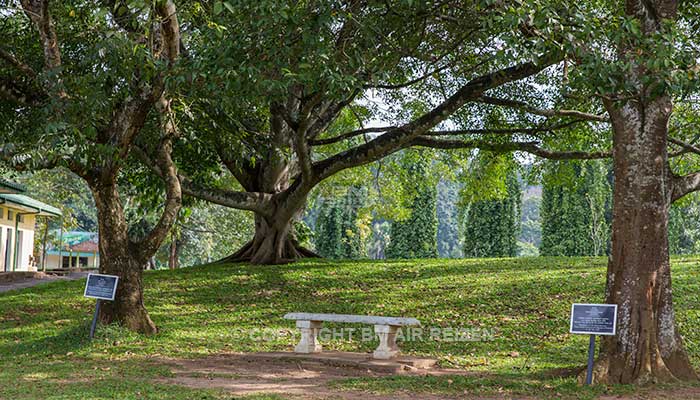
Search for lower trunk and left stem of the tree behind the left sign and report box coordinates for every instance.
[91,183,157,334]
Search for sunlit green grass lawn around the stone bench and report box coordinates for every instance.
[0,257,700,399]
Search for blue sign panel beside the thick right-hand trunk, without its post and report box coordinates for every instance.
[569,304,617,336]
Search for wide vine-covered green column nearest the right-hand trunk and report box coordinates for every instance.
[540,161,612,256]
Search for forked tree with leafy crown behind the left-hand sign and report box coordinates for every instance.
[0,0,181,333]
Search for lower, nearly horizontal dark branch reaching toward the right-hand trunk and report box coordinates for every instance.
[411,136,612,160]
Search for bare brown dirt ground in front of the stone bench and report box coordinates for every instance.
[158,354,700,400]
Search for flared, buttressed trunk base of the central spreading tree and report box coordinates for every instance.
[220,213,319,264]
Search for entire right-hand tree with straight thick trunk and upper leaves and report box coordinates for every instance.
[582,0,700,383]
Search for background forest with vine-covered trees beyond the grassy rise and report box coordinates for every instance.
[13,155,700,268]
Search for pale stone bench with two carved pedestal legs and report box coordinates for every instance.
[284,313,420,360]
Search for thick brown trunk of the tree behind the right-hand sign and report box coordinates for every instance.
[596,96,697,384]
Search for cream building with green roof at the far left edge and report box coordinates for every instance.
[0,179,61,272]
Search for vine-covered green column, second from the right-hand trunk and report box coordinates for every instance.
[463,171,521,257]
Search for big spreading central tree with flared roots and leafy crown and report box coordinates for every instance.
[141,0,602,263]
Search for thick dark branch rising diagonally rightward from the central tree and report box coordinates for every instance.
[314,53,563,181]
